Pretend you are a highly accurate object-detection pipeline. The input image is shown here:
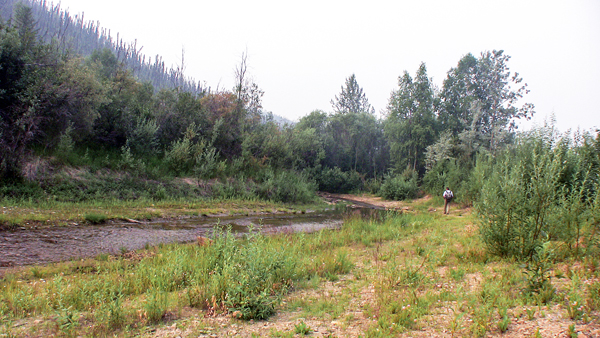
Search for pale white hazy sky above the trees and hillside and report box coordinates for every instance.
[54,0,600,131]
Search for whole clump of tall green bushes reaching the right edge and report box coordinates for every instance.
[475,127,597,259]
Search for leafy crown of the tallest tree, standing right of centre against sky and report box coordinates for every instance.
[439,50,533,152]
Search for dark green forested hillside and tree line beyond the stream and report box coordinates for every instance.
[0,0,600,217]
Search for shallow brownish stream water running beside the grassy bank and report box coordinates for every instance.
[0,211,343,267]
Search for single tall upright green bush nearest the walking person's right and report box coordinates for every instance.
[476,128,563,258]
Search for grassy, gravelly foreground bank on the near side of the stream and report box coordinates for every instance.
[0,198,600,337]
